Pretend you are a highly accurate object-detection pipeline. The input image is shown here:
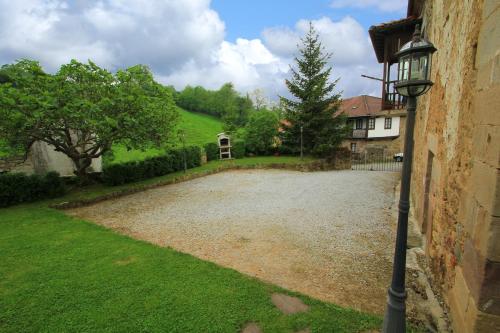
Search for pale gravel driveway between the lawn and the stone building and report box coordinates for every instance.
[69,170,398,313]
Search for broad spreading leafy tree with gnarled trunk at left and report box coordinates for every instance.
[0,60,177,179]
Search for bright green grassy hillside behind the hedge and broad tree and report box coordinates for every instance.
[105,108,222,163]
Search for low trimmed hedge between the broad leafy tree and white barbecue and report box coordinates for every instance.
[102,146,201,186]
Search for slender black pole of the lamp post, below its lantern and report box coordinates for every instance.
[383,97,417,333]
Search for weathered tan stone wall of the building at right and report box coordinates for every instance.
[411,0,500,332]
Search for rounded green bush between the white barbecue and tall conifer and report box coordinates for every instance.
[245,109,279,155]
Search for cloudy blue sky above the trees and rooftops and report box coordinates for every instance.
[0,0,407,100]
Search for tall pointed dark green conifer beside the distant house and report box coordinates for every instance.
[280,23,347,156]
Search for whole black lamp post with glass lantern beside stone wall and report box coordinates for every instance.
[383,25,436,333]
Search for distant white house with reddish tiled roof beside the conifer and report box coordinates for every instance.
[340,95,406,154]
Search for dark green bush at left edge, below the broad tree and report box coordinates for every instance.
[0,172,66,207]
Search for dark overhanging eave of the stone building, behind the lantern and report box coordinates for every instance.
[368,16,422,63]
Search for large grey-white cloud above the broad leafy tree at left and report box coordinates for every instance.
[0,0,225,74]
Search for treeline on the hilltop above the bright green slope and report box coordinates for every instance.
[175,83,254,132]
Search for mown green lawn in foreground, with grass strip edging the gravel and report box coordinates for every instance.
[0,157,388,332]
